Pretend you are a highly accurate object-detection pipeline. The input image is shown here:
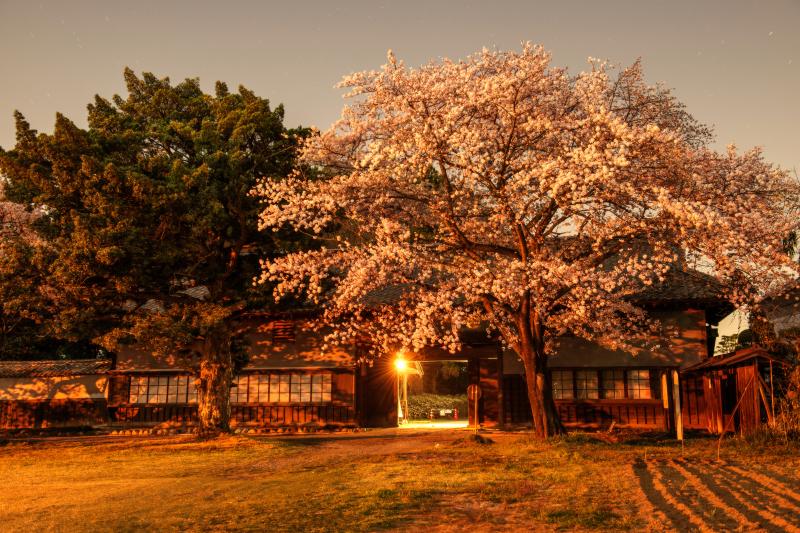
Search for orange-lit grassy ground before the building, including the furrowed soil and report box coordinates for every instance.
[0,430,800,532]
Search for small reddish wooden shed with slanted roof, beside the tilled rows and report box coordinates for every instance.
[681,346,789,434]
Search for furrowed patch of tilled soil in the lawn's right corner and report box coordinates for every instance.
[633,459,800,532]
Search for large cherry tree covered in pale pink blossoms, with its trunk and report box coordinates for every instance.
[254,44,797,437]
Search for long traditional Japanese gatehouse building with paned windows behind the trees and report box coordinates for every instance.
[0,272,744,430]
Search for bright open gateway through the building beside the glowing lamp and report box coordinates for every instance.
[398,359,469,429]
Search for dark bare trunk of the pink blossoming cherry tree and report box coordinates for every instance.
[519,336,564,439]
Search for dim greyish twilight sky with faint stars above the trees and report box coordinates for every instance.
[0,0,800,172]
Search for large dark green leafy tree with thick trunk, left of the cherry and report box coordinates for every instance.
[0,69,305,432]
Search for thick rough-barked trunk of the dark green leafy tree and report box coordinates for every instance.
[197,333,233,436]
